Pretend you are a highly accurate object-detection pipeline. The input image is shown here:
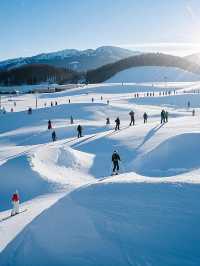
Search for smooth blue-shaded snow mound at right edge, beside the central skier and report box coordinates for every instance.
[133,133,200,177]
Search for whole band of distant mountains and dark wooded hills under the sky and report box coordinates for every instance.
[0,46,200,86]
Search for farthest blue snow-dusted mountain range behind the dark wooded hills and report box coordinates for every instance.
[0,46,140,72]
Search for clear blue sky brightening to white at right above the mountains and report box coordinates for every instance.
[0,0,200,60]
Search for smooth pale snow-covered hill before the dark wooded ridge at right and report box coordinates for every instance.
[106,66,200,83]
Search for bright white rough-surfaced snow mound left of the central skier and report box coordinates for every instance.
[32,145,94,185]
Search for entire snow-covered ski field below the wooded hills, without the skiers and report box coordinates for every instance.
[0,80,200,266]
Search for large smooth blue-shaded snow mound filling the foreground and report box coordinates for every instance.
[0,182,200,266]
